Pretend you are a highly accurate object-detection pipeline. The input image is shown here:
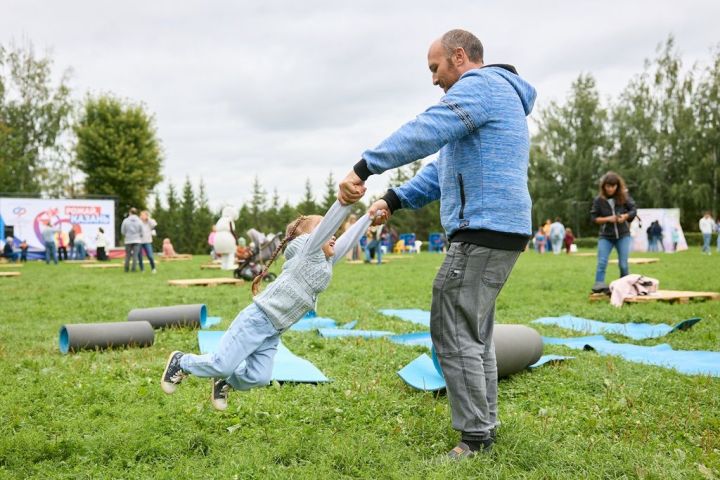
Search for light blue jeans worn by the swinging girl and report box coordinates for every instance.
[180,303,280,390]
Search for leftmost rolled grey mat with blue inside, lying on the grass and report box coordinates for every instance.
[60,322,155,353]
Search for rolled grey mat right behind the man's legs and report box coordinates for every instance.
[493,324,543,377]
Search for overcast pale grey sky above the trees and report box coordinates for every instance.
[0,0,720,207]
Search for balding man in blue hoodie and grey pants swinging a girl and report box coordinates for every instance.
[338,30,535,458]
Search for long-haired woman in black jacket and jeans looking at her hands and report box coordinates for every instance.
[590,172,637,293]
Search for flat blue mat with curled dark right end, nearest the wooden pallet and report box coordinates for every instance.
[532,315,700,340]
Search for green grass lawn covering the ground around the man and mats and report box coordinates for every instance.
[0,249,720,479]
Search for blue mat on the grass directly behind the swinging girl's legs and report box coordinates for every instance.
[198,330,330,383]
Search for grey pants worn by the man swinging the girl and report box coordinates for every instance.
[430,243,520,440]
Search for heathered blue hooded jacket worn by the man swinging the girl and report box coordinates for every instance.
[355,65,536,250]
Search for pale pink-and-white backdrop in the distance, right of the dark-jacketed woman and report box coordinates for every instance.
[630,208,687,253]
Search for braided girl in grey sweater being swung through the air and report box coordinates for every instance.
[160,202,370,410]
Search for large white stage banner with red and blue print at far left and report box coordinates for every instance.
[0,197,115,258]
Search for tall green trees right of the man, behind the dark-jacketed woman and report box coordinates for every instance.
[529,36,720,236]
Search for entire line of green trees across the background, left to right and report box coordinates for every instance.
[0,37,720,252]
